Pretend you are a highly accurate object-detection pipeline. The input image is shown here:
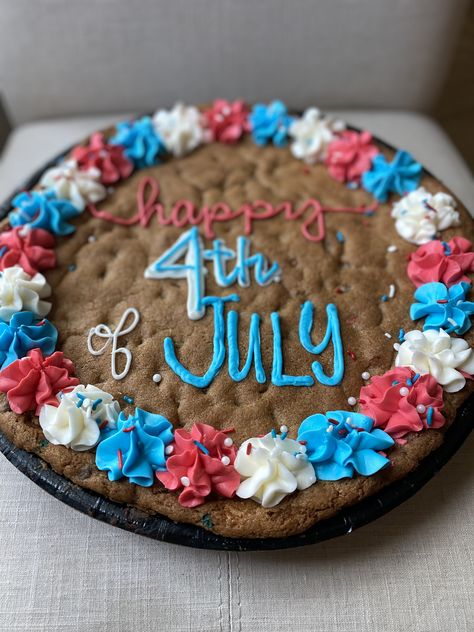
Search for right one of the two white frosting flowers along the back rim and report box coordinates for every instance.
[288,108,345,164]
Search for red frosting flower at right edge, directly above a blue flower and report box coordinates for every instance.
[407,237,474,287]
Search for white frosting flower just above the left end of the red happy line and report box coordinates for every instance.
[40,160,107,211]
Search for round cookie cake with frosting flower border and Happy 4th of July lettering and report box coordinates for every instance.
[0,100,474,538]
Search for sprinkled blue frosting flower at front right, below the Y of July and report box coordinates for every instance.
[298,410,394,481]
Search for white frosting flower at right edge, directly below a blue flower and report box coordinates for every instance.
[395,329,474,393]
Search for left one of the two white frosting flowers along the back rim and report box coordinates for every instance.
[153,103,204,158]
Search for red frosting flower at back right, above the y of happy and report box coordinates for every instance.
[325,130,380,182]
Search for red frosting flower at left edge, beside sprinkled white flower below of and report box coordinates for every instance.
[0,349,79,415]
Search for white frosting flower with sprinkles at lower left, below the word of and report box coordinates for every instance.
[39,384,120,452]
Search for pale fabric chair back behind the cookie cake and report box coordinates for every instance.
[0,0,469,124]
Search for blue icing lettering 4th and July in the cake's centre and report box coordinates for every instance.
[145,232,344,388]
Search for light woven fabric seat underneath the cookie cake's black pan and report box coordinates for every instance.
[0,112,474,632]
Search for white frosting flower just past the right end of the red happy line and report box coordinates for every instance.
[392,187,459,246]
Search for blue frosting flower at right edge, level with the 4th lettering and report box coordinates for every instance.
[410,281,474,335]
